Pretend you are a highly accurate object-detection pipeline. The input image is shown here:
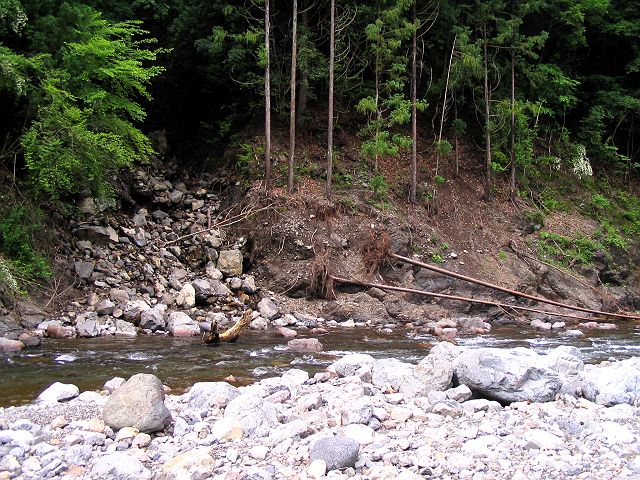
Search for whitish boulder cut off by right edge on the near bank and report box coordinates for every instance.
[580,357,640,405]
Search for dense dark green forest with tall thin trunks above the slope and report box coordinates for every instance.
[0,0,640,286]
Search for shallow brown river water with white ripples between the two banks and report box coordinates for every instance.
[0,322,640,406]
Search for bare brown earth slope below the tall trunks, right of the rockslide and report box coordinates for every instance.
[216,124,640,326]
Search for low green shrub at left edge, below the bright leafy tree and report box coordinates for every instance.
[0,204,51,282]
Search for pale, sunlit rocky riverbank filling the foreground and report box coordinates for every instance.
[0,343,640,480]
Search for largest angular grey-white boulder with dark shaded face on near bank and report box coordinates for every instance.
[455,348,562,402]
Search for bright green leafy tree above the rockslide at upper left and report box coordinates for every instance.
[22,12,162,200]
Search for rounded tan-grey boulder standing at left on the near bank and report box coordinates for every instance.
[102,373,171,433]
